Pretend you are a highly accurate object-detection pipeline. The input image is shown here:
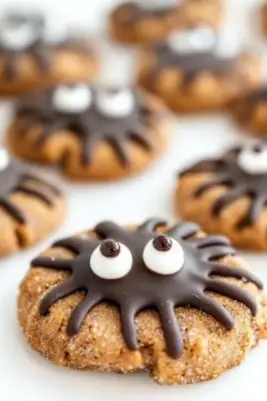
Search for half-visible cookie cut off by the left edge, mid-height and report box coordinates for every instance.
[0,148,66,257]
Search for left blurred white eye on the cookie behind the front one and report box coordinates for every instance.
[52,84,92,113]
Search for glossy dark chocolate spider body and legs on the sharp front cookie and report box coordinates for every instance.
[32,219,262,358]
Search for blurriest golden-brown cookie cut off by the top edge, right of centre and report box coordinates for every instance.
[110,0,223,44]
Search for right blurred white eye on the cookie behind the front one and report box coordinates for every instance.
[96,89,135,118]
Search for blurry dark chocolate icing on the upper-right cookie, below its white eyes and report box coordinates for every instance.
[147,42,235,88]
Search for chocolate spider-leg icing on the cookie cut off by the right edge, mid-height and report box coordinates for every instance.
[180,145,267,229]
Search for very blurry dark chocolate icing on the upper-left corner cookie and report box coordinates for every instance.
[0,13,88,79]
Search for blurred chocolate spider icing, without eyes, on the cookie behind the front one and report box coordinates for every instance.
[17,88,157,166]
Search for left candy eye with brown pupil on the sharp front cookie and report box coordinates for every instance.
[90,239,133,280]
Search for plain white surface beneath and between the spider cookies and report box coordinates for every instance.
[0,0,267,401]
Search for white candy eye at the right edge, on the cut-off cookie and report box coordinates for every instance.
[237,144,267,175]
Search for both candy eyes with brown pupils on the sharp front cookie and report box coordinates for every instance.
[90,235,184,280]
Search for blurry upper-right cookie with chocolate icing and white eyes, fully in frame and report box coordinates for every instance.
[139,26,261,112]
